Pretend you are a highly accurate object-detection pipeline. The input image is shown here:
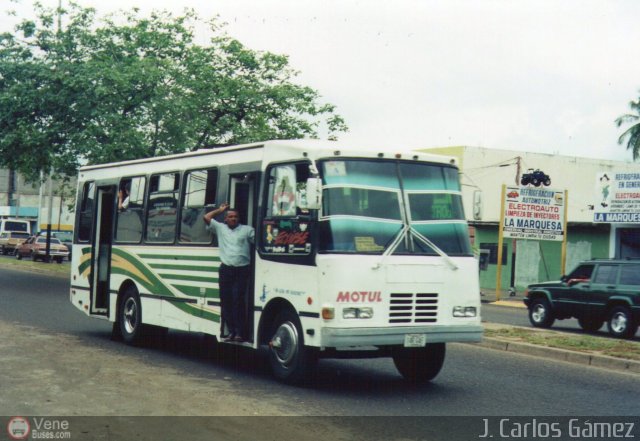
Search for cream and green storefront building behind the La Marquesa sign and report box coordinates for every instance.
[424,146,640,291]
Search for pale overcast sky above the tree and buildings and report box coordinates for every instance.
[0,0,640,161]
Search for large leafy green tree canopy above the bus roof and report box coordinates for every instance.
[0,3,347,179]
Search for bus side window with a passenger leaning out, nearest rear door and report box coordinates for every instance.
[116,177,146,243]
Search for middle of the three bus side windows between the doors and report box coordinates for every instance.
[146,173,180,243]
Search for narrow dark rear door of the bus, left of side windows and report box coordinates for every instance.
[91,185,116,315]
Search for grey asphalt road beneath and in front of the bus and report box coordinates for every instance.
[0,262,640,422]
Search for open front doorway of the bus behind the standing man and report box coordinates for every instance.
[229,173,260,336]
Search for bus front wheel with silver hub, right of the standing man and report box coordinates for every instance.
[269,310,317,384]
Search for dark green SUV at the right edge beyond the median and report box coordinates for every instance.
[524,259,640,338]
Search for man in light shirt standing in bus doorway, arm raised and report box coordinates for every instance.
[203,203,255,342]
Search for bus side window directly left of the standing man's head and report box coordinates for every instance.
[180,169,218,246]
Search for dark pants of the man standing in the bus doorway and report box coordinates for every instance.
[218,263,250,338]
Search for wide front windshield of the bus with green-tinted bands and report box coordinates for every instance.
[318,159,471,255]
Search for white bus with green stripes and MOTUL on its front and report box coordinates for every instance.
[70,141,482,382]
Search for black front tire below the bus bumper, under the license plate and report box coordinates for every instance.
[392,343,447,385]
